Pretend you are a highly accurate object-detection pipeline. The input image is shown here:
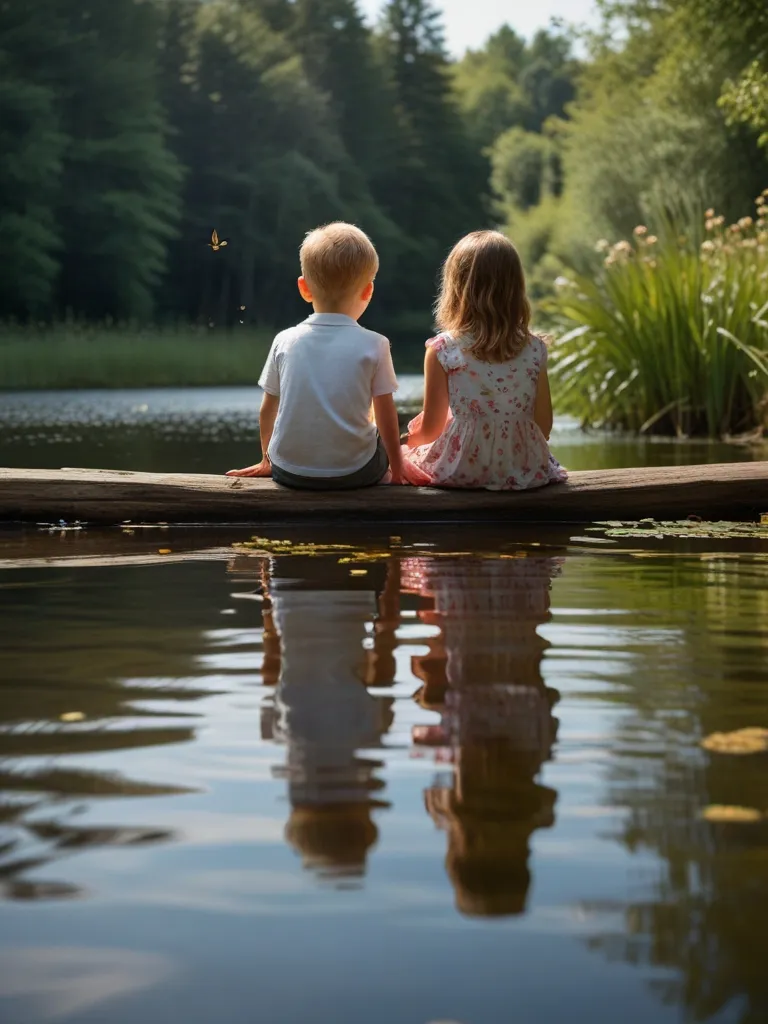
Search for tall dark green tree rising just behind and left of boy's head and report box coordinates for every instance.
[158,0,378,323]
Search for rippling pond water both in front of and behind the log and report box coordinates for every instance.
[0,391,768,1024]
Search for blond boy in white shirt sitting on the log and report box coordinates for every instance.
[227,223,404,490]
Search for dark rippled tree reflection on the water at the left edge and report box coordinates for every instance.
[0,570,218,900]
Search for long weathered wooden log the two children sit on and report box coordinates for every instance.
[0,462,768,526]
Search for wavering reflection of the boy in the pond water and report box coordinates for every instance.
[265,557,397,880]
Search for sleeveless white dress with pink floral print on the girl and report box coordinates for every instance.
[402,334,567,490]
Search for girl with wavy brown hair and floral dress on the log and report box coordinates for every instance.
[402,231,567,490]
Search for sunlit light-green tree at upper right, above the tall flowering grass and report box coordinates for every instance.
[565,0,768,232]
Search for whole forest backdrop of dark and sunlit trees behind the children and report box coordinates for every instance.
[0,0,768,332]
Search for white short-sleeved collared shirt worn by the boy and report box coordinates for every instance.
[259,313,397,476]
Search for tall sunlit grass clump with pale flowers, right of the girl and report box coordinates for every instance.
[547,189,768,437]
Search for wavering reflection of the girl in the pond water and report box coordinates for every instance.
[402,557,561,916]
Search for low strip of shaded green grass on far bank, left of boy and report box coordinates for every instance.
[0,325,272,390]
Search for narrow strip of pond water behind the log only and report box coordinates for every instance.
[0,385,768,473]
